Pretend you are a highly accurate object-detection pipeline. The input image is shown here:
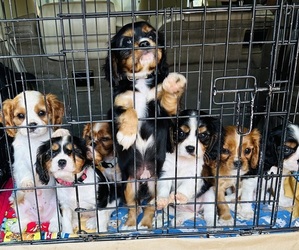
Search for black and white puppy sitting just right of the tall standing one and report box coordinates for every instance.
[157,110,220,226]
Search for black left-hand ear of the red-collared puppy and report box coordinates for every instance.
[35,143,50,185]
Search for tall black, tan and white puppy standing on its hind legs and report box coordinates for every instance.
[105,22,186,228]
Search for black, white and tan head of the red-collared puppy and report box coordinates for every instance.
[36,135,88,184]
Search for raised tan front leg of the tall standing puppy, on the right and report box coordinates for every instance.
[158,73,187,115]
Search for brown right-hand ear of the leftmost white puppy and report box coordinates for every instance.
[46,94,64,130]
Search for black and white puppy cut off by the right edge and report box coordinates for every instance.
[263,123,299,207]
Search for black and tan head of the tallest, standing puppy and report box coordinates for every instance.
[105,22,168,84]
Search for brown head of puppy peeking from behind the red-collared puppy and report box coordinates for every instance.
[83,122,113,163]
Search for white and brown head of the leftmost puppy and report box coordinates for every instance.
[2,91,64,137]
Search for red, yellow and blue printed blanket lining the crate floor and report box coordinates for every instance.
[0,177,299,242]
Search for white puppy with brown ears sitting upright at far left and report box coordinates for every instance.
[1,91,64,232]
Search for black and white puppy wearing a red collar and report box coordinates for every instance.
[36,135,117,233]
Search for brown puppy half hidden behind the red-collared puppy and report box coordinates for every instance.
[83,122,121,181]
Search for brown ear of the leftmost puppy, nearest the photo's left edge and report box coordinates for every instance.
[0,99,17,137]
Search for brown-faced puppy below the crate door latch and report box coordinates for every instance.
[211,126,261,225]
